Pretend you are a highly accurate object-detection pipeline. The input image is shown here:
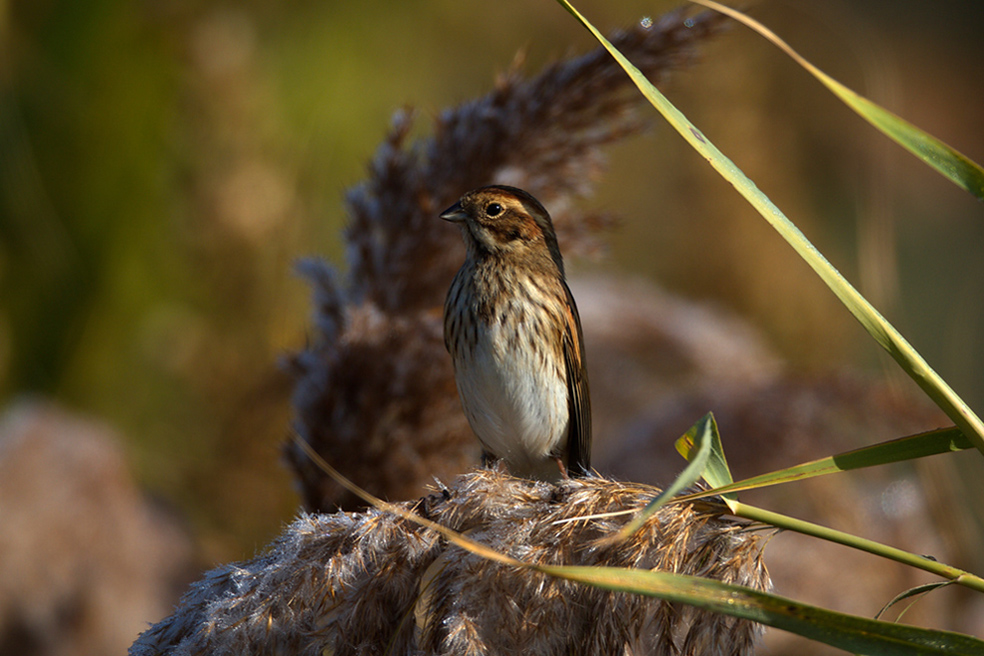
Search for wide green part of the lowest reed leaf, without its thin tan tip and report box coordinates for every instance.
[536,567,984,656]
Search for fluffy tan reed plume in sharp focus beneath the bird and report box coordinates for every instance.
[130,470,769,656]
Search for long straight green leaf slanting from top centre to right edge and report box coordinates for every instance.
[557,0,984,454]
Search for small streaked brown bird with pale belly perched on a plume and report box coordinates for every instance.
[441,186,591,481]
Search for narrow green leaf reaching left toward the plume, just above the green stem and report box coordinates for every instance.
[675,428,973,501]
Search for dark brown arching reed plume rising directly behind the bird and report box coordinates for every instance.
[286,12,722,510]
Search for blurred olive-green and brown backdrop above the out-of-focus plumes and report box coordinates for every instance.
[0,0,984,652]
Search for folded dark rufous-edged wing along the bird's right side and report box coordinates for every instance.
[561,281,591,476]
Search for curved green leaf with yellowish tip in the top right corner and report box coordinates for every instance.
[690,0,984,200]
